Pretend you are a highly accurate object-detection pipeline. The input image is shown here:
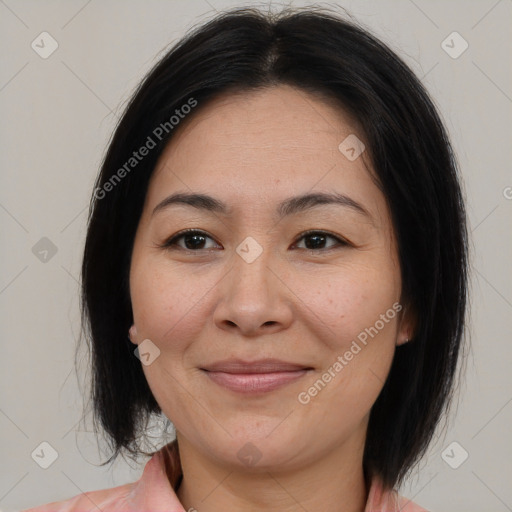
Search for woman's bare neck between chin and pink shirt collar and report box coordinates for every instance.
[176,433,368,512]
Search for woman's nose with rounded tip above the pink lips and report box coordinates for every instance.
[214,249,293,337]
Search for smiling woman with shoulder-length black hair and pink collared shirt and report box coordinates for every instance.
[26,5,467,512]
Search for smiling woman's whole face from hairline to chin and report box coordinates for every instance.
[130,86,407,468]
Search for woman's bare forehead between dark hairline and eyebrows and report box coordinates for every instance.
[148,85,379,218]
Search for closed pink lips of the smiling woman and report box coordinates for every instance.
[201,359,313,394]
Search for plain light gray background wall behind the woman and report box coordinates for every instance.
[0,0,512,512]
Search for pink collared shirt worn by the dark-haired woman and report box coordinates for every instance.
[21,441,427,512]
